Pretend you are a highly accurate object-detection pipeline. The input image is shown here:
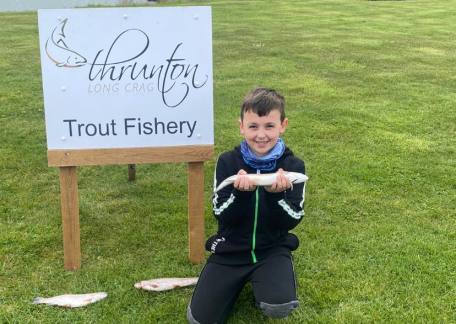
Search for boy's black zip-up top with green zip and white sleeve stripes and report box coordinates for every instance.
[206,146,305,264]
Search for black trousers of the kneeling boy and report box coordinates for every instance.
[189,254,297,324]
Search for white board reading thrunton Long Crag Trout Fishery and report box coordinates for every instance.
[38,7,214,150]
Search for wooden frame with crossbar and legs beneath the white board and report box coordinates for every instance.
[48,145,214,270]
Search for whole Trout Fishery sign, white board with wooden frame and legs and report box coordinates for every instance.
[38,7,214,270]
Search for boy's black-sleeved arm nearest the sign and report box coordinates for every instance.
[212,155,254,225]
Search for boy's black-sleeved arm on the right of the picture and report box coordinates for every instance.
[266,160,306,230]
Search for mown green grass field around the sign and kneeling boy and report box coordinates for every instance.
[0,0,456,323]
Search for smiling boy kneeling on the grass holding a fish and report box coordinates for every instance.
[187,88,305,324]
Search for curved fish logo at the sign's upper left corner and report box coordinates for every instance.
[45,18,87,68]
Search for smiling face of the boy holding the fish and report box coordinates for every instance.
[239,109,288,156]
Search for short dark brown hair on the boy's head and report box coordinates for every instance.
[241,87,285,121]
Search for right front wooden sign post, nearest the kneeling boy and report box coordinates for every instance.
[188,162,204,263]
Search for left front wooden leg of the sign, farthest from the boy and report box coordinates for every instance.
[60,166,81,270]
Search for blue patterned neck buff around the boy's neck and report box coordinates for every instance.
[241,138,285,171]
